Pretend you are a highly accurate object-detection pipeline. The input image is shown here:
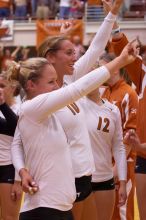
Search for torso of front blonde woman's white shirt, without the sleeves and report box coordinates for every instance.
[16,112,75,211]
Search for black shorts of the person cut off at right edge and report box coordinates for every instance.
[135,156,146,174]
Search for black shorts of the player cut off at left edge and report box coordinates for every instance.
[0,164,15,184]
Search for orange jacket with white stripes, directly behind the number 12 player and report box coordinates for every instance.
[102,79,138,160]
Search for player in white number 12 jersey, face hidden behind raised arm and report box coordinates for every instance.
[82,89,127,220]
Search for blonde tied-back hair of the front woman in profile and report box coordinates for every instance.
[7,57,51,90]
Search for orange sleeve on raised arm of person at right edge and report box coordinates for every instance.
[112,34,145,94]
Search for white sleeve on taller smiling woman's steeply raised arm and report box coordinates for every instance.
[65,12,116,84]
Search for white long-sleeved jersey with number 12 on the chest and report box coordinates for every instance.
[82,98,127,182]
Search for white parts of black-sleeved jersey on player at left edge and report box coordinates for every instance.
[0,104,20,166]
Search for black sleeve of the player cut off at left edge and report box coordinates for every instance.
[0,103,18,136]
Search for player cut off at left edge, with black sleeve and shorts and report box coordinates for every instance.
[0,73,22,220]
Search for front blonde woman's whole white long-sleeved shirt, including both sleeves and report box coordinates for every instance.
[11,66,110,211]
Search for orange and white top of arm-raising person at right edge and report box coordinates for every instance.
[112,34,146,157]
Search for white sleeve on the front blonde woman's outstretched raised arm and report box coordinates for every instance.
[21,66,110,123]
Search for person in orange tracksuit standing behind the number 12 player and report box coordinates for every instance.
[99,51,138,220]
